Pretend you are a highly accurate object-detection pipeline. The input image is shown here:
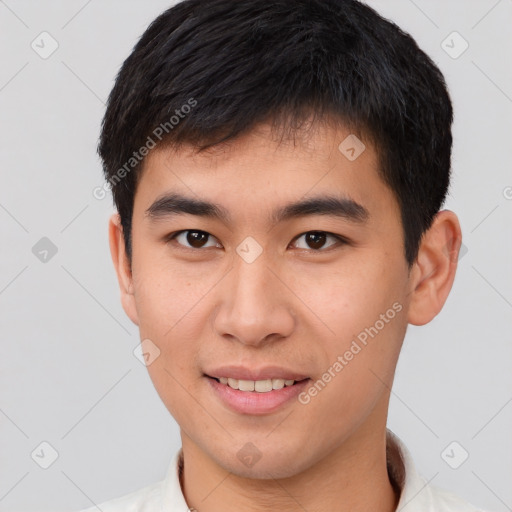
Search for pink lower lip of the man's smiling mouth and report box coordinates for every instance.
[206,377,310,414]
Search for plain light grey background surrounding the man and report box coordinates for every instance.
[0,0,512,512]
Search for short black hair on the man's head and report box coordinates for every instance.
[98,0,453,268]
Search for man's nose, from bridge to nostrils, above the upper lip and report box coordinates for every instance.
[213,254,296,346]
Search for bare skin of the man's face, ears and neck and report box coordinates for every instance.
[109,121,461,512]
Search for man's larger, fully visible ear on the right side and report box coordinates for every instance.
[408,210,462,325]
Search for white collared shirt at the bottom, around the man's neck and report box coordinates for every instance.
[76,429,484,512]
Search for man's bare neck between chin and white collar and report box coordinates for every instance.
[180,418,400,512]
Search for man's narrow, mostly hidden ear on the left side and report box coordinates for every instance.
[108,213,139,325]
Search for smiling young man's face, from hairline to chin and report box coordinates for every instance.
[114,126,411,478]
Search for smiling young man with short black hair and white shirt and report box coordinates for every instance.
[79,0,488,512]
